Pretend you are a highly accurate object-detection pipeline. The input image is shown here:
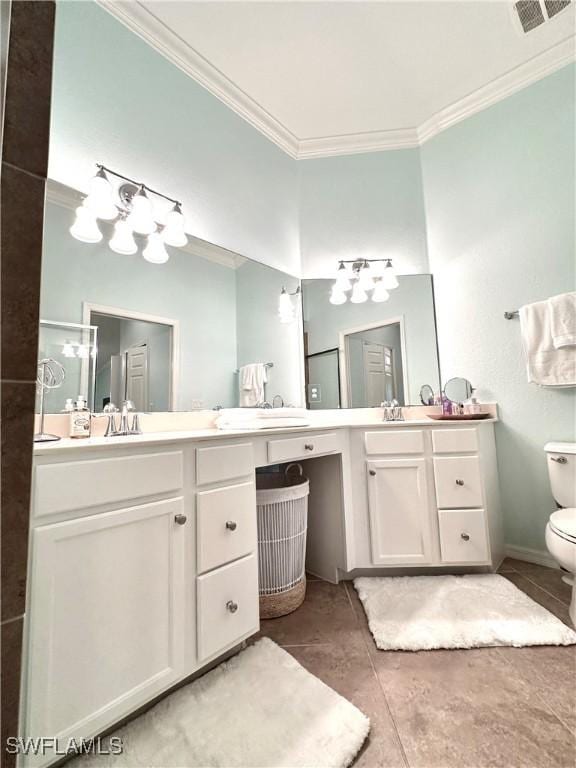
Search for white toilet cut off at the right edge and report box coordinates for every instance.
[544,443,576,626]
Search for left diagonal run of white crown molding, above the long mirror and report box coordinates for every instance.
[96,0,298,158]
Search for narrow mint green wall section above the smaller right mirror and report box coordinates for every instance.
[299,149,429,278]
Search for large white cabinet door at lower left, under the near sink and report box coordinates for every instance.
[25,498,187,762]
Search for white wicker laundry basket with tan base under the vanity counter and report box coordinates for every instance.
[256,464,310,619]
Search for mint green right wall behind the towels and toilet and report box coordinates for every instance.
[422,65,576,551]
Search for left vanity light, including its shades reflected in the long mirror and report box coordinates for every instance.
[70,164,188,264]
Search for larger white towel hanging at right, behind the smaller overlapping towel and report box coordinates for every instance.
[519,301,576,387]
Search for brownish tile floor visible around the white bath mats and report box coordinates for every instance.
[261,559,576,768]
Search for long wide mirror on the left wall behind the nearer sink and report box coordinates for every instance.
[39,195,304,413]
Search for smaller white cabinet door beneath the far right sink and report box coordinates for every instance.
[366,459,432,565]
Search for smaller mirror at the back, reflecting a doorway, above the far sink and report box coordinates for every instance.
[302,274,440,409]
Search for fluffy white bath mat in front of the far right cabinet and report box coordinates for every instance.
[354,574,576,651]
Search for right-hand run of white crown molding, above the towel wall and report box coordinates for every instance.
[418,35,576,145]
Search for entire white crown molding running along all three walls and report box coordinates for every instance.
[96,0,576,160]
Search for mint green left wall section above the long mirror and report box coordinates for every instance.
[49,0,300,274]
